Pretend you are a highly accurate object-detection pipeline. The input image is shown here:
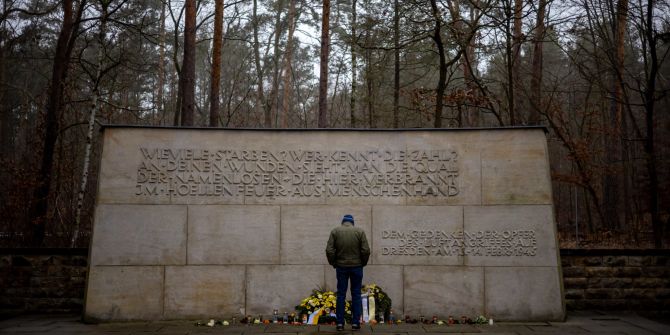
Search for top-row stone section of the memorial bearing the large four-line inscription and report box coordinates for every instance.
[99,128,490,205]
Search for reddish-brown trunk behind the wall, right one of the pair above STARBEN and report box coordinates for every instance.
[209,0,223,127]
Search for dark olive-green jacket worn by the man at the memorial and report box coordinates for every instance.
[326,222,370,268]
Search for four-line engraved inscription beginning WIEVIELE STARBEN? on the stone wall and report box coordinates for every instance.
[135,147,460,198]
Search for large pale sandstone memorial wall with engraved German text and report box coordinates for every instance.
[85,127,564,320]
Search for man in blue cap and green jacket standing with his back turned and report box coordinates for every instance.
[326,214,370,331]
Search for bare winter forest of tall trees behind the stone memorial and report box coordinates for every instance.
[0,0,670,248]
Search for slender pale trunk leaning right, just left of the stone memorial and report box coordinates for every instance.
[70,1,110,248]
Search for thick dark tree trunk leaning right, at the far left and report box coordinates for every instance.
[30,0,86,246]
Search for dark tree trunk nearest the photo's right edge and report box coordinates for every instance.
[644,1,665,248]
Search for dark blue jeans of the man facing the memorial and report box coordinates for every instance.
[335,266,363,325]
